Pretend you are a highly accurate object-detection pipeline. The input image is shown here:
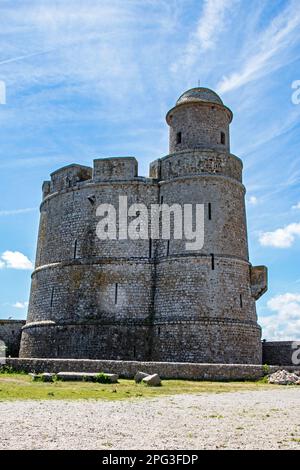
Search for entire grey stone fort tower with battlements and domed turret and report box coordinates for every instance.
[20,88,267,364]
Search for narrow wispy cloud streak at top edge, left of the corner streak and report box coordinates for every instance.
[172,0,237,71]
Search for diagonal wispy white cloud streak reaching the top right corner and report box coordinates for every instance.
[217,2,300,93]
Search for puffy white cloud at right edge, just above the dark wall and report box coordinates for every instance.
[260,292,300,341]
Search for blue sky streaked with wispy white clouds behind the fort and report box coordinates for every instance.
[0,0,300,339]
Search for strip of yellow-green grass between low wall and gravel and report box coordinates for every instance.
[0,373,276,401]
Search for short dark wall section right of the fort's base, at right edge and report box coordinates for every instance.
[262,341,300,366]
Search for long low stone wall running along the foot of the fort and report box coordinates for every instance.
[6,358,300,381]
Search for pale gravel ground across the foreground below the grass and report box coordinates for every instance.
[0,387,300,450]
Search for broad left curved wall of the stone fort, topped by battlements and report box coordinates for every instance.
[21,159,158,360]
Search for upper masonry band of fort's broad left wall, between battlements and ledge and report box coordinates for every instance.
[36,180,158,267]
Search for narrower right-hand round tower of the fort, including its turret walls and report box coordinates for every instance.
[152,90,261,363]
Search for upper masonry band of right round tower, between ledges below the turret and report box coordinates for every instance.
[158,175,248,260]
